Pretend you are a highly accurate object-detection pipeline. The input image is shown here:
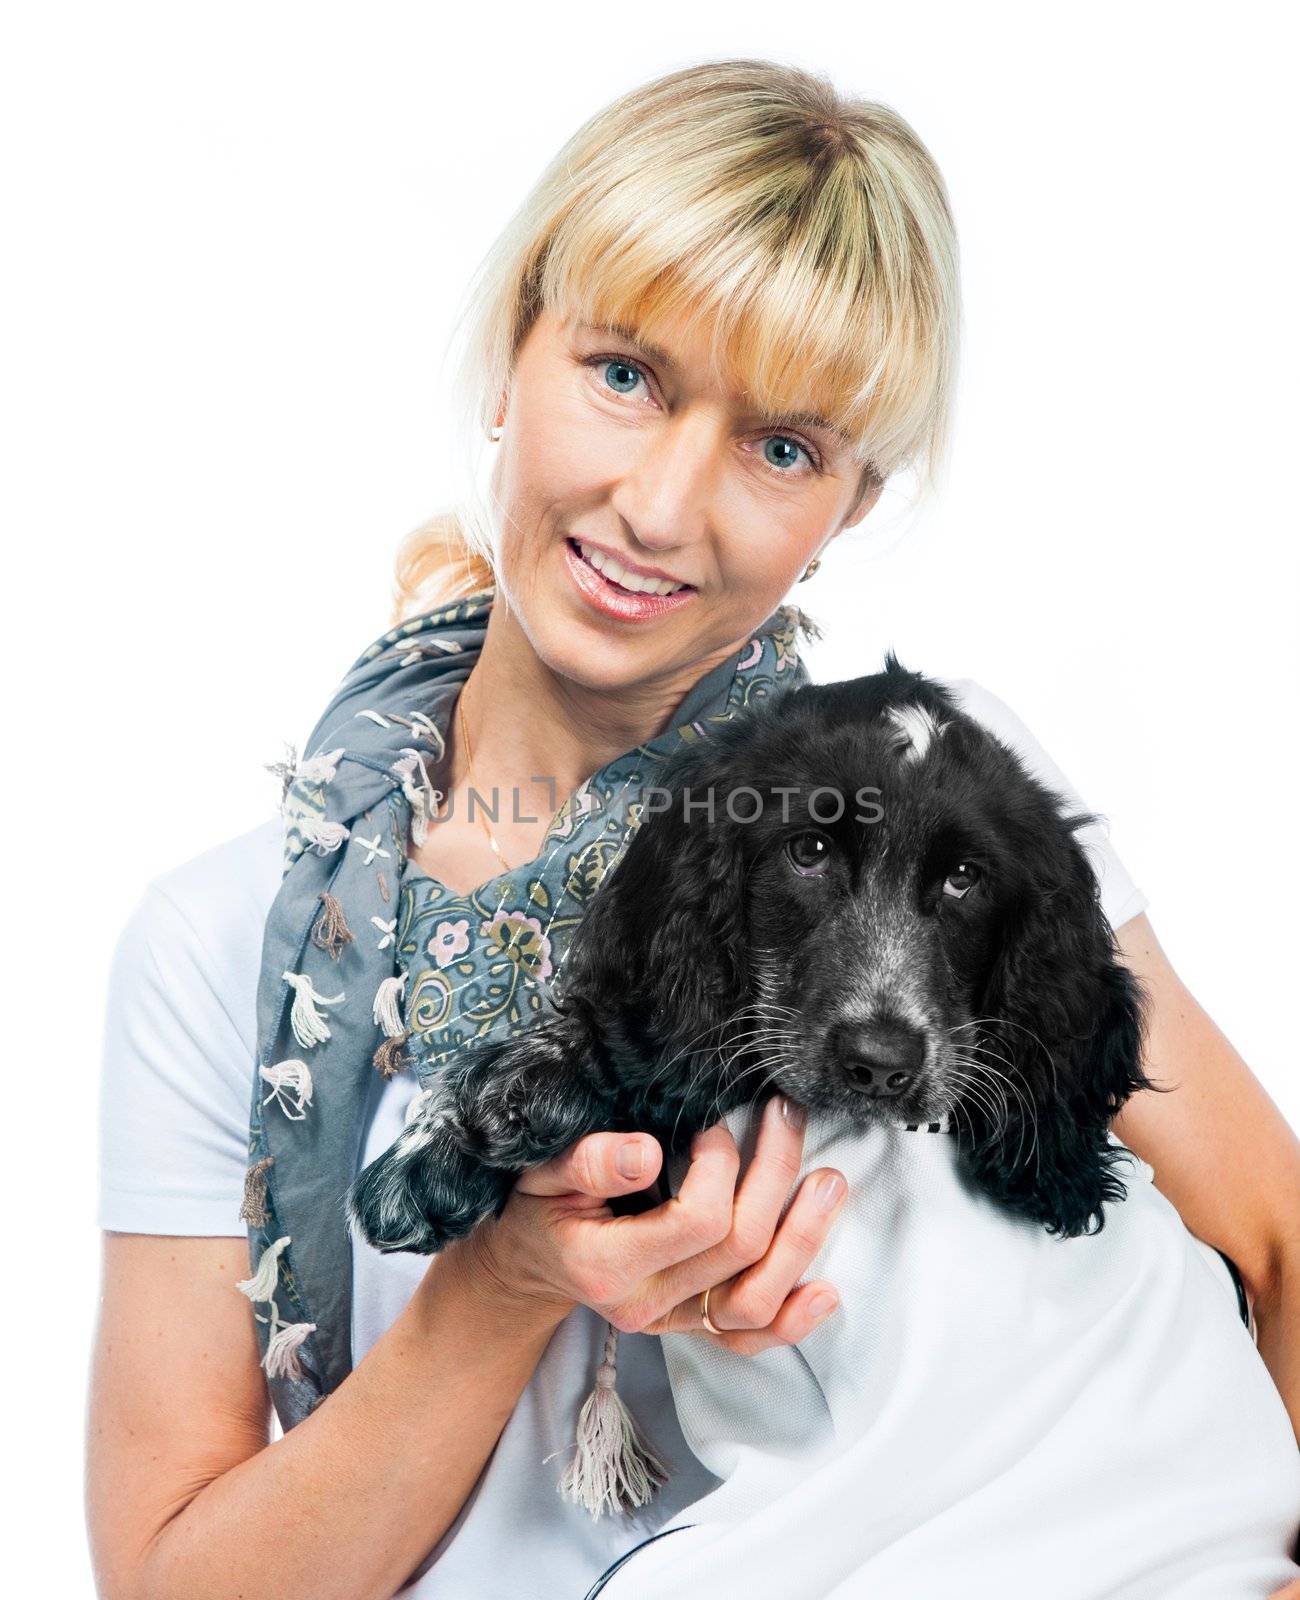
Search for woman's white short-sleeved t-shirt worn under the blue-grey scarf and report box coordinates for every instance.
[98,680,1146,1600]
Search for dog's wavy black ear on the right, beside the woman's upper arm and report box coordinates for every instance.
[959,818,1154,1237]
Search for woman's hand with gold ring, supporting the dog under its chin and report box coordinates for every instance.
[463,1096,849,1355]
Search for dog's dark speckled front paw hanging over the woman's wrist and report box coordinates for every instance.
[346,1094,512,1256]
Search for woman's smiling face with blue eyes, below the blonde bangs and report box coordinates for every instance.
[492,312,879,704]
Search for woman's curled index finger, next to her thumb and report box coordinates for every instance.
[582,1122,740,1278]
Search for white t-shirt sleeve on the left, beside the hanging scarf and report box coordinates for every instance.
[98,830,275,1235]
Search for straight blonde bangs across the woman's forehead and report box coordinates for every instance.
[536,142,951,478]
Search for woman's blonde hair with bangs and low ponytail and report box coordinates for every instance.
[394,61,961,621]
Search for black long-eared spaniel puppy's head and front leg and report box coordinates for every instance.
[347,654,1151,1254]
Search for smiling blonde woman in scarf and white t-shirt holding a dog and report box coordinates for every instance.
[90,61,1300,1600]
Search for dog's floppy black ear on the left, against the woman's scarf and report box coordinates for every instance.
[567,742,748,1050]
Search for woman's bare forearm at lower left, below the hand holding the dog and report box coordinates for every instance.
[136,1248,562,1600]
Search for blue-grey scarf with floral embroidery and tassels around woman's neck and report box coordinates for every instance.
[239,589,813,1432]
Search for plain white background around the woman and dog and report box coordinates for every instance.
[0,0,1300,1595]
